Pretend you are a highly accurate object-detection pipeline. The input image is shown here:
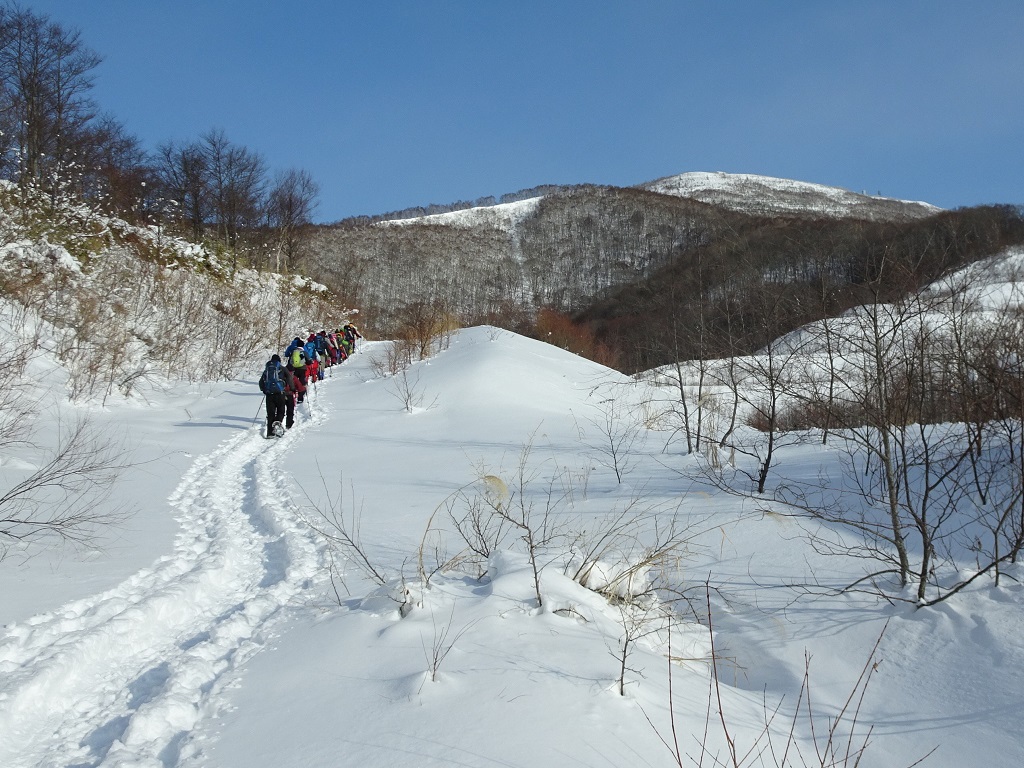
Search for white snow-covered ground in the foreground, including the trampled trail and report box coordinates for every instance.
[0,329,1024,768]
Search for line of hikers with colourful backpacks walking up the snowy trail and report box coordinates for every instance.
[259,323,362,437]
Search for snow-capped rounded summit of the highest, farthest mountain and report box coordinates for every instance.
[640,172,941,220]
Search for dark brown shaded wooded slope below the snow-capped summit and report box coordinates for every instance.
[574,206,1024,372]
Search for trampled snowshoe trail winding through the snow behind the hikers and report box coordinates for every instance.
[0,419,318,768]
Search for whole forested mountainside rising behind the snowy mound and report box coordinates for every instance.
[300,177,1024,371]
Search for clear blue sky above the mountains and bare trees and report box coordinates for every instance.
[24,0,1024,221]
